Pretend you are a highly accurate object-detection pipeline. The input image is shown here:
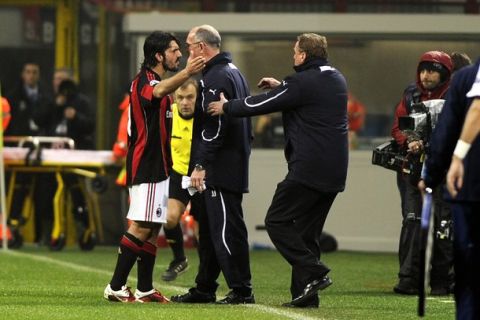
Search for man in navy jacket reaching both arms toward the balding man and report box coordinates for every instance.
[209,33,348,307]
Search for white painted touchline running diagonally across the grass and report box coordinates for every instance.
[4,250,325,320]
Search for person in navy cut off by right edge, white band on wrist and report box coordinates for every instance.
[420,60,480,320]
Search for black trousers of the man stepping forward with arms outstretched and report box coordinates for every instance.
[265,180,337,303]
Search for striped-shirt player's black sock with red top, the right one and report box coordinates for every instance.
[137,241,157,292]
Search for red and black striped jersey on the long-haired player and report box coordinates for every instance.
[127,68,172,186]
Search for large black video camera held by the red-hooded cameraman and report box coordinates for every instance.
[372,99,445,178]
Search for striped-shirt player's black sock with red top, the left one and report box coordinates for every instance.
[110,232,143,291]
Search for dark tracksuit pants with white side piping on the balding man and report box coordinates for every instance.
[195,187,252,296]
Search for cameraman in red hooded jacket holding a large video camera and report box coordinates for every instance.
[392,51,453,295]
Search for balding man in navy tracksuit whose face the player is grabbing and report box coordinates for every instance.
[172,25,255,304]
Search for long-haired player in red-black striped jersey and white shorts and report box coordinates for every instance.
[104,31,205,303]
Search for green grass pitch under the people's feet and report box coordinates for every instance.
[0,246,455,320]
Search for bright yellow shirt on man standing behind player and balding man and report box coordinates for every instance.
[171,103,193,176]
